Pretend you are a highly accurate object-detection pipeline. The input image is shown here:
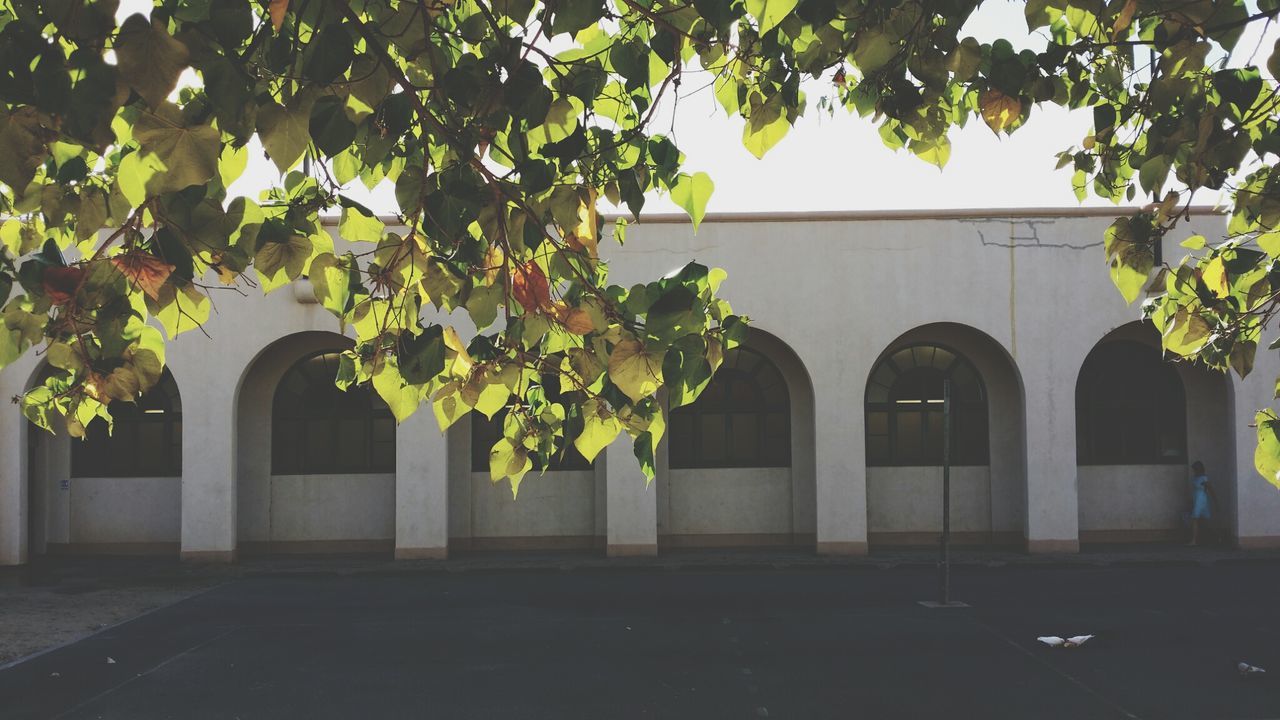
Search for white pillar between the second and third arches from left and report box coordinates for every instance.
[396,402,449,560]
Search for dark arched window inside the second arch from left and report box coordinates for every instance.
[271,352,396,475]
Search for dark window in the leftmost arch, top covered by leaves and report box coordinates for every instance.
[72,369,182,478]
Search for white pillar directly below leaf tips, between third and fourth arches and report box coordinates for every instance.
[603,433,658,557]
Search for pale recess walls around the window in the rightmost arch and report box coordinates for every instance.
[1076,322,1238,543]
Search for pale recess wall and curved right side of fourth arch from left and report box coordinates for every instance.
[655,327,817,547]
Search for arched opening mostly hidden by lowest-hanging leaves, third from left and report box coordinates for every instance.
[449,378,605,551]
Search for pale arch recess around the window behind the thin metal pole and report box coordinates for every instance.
[861,322,1027,547]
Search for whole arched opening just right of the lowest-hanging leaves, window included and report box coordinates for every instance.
[657,328,817,547]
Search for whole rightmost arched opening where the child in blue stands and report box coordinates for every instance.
[1075,323,1235,543]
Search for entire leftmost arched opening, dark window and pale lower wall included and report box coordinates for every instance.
[27,368,182,556]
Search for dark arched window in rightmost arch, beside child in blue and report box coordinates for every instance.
[1075,341,1187,465]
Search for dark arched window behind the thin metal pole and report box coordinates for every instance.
[867,345,989,465]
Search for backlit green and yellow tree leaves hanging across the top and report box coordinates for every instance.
[0,0,1280,488]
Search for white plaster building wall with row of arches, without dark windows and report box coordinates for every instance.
[0,204,1280,564]
